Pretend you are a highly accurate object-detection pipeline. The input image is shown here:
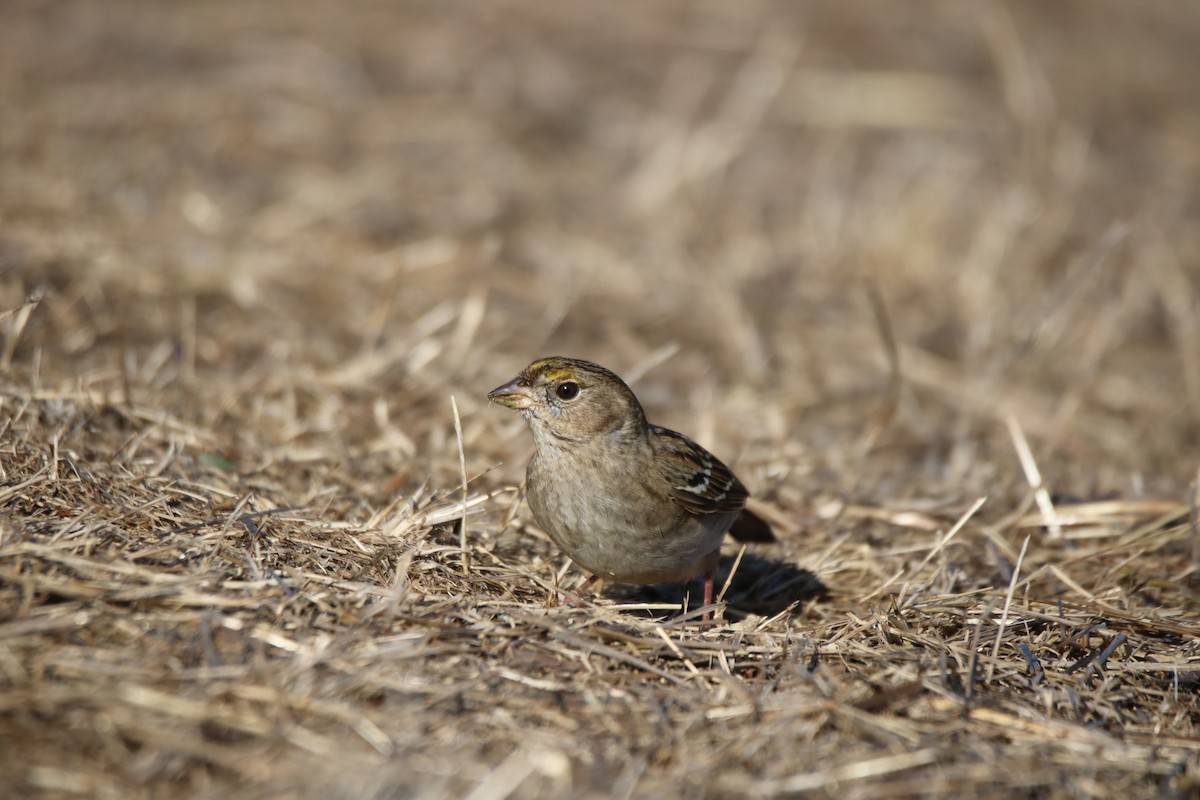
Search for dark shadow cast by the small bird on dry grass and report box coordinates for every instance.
[604,552,829,620]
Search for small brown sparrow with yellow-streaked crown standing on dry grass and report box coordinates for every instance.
[487,357,774,618]
